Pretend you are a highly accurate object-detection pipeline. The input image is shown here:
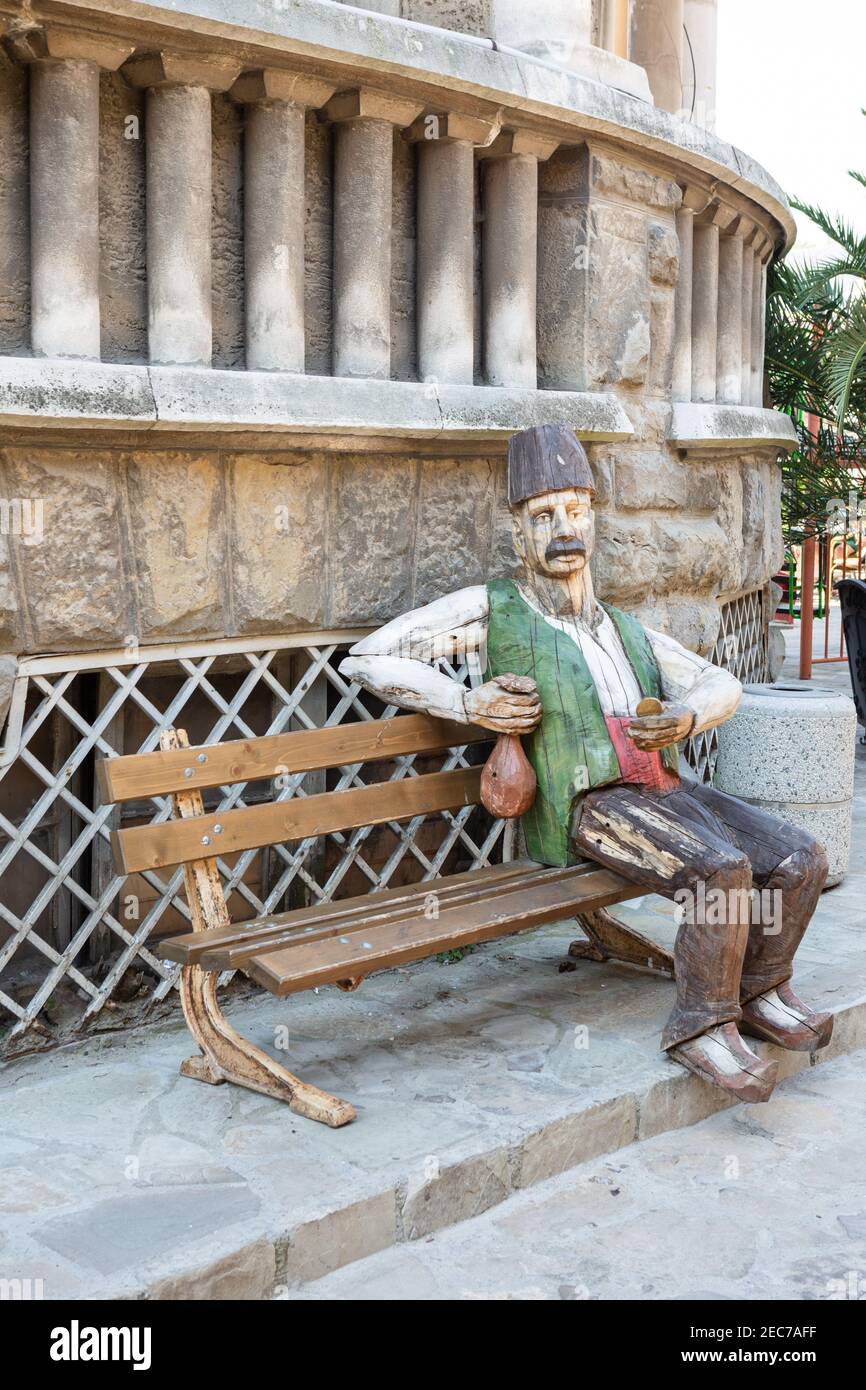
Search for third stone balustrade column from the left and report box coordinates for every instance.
[229,68,334,373]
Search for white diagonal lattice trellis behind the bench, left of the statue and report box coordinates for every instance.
[0,632,507,1043]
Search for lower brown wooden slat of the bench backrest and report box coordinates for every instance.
[111,767,482,874]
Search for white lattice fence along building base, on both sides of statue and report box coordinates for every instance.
[0,591,766,1056]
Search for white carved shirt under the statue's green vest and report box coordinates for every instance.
[339,584,741,734]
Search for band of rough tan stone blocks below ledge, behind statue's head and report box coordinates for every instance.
[0,439,781,653]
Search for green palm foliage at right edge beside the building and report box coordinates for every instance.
[765,113,866,542]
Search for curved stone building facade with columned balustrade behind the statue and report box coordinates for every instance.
[0,0,792,1033]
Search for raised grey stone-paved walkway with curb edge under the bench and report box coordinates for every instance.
[0,656,866,1298]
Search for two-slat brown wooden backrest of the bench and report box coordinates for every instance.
[96,714,492,874]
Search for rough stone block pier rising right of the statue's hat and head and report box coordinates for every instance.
[538,142,783,652]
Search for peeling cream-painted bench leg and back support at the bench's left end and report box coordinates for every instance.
[160,728,354,1129]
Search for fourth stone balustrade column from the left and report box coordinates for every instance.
[325,88,421,378]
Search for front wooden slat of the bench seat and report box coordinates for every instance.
[245,866,642,995]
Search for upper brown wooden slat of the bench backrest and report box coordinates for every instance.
[96,714,492,802]
